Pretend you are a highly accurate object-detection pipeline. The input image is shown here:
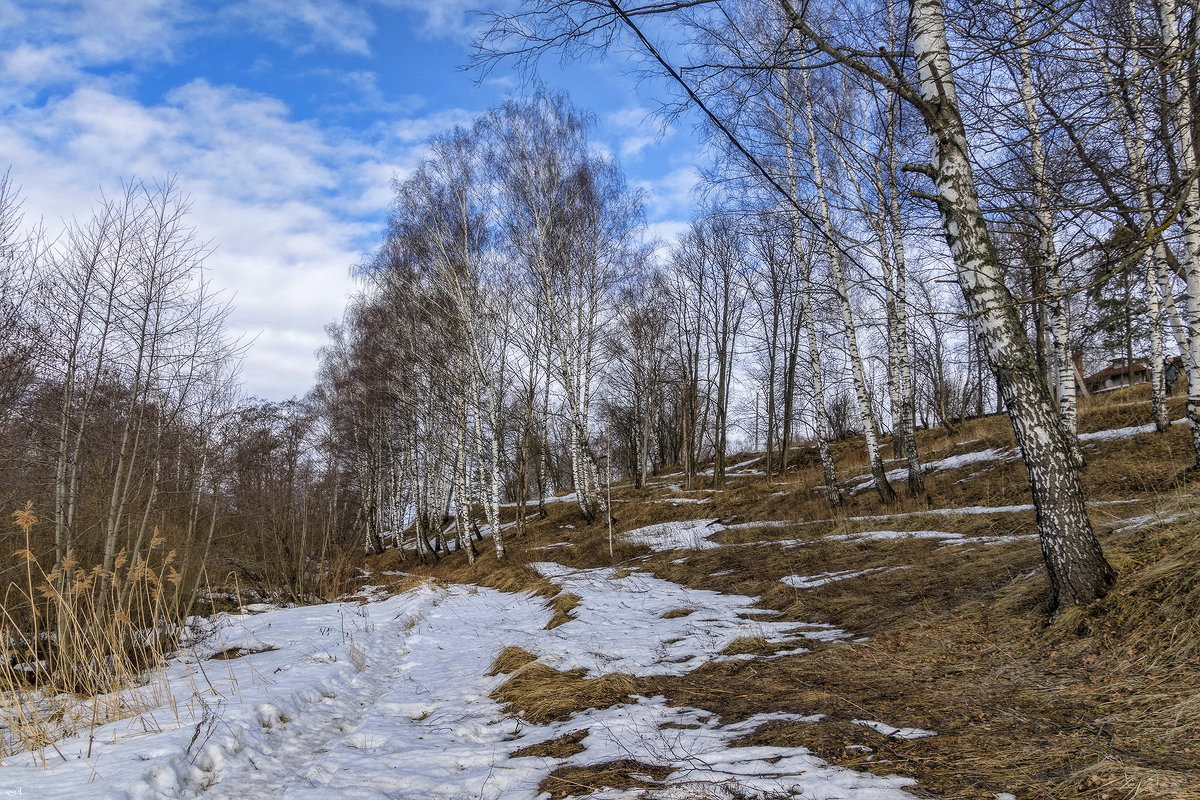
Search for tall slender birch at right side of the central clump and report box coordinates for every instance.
[486,94,641,522]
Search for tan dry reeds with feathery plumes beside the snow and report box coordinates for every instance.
[0,505,184,763]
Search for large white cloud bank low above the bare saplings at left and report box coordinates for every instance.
[0,80,419,398]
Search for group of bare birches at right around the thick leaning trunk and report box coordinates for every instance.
[446,0,1200,609]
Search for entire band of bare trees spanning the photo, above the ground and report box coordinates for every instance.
[7,0,1200,623]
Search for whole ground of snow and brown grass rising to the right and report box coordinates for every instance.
[0,387,1200,800]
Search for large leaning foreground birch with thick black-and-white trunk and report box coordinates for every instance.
[472,0,1118,613]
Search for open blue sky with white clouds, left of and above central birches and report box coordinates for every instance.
[0,0,696,399]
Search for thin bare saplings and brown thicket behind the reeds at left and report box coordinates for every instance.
[0,176,352,606]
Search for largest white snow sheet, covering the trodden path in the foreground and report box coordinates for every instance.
[0,563,912,800]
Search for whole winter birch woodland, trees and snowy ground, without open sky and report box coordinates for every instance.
[0,0,1200,800]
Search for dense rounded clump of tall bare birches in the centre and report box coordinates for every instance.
[318,95,647,559]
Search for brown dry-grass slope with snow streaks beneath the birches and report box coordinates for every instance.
[371,387,1200,800]
